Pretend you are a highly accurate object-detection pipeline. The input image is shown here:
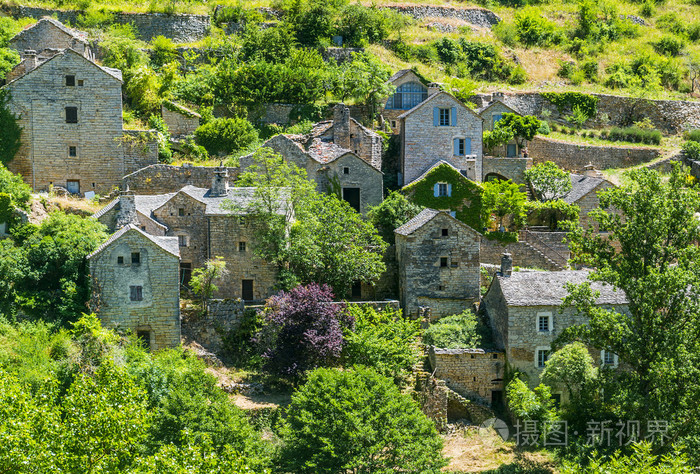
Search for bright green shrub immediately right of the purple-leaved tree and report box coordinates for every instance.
[343,305,420,383]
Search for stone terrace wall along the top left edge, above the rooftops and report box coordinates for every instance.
[2,5,211,43]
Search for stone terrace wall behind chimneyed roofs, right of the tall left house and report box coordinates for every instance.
[122,164,238,194]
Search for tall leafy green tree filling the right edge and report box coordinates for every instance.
[562,166,700,453]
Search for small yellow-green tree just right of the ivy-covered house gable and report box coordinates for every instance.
[482,179,527,229]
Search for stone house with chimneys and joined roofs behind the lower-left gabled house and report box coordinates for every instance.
[94,167,284,301]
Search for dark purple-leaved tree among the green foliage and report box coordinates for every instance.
[258,283,355,378]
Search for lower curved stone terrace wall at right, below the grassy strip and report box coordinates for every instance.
[528,137,661,171]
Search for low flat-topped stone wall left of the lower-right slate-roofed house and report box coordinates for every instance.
[428,346,505,404]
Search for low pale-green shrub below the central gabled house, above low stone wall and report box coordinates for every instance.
[423,310,489,349]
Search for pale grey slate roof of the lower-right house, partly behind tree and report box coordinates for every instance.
[496,270,627,306]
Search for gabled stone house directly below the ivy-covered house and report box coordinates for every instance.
[394,209,481,318]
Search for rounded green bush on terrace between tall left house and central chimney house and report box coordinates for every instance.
[194,117,258,155]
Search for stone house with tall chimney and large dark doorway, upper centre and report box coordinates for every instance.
[240,104,384,214]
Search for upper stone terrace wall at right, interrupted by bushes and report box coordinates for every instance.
[471,92,700,133]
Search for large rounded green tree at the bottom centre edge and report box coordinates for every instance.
[281,367,446,474]
